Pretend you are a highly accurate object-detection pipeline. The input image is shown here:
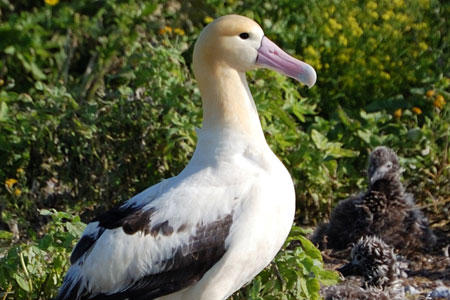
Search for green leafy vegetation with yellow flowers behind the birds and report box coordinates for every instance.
[0,0,450,300]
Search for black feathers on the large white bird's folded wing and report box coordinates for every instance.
[56,206,233,300]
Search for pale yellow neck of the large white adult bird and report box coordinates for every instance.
[194,63,265,143]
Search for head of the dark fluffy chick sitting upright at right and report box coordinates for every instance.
[369,146,400,186]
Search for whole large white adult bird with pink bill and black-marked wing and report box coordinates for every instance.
[56,15,316,300]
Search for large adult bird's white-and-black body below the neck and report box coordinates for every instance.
[59,127,295,299]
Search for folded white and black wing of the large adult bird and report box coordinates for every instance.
[57,164,249,299]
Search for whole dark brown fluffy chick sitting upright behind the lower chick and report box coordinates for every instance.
[312,147,435,250]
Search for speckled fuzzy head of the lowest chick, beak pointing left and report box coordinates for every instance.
[338,236,399,287]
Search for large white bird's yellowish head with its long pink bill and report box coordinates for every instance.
[193,15,317,87]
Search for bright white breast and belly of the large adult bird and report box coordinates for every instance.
[161,127,295,300]
